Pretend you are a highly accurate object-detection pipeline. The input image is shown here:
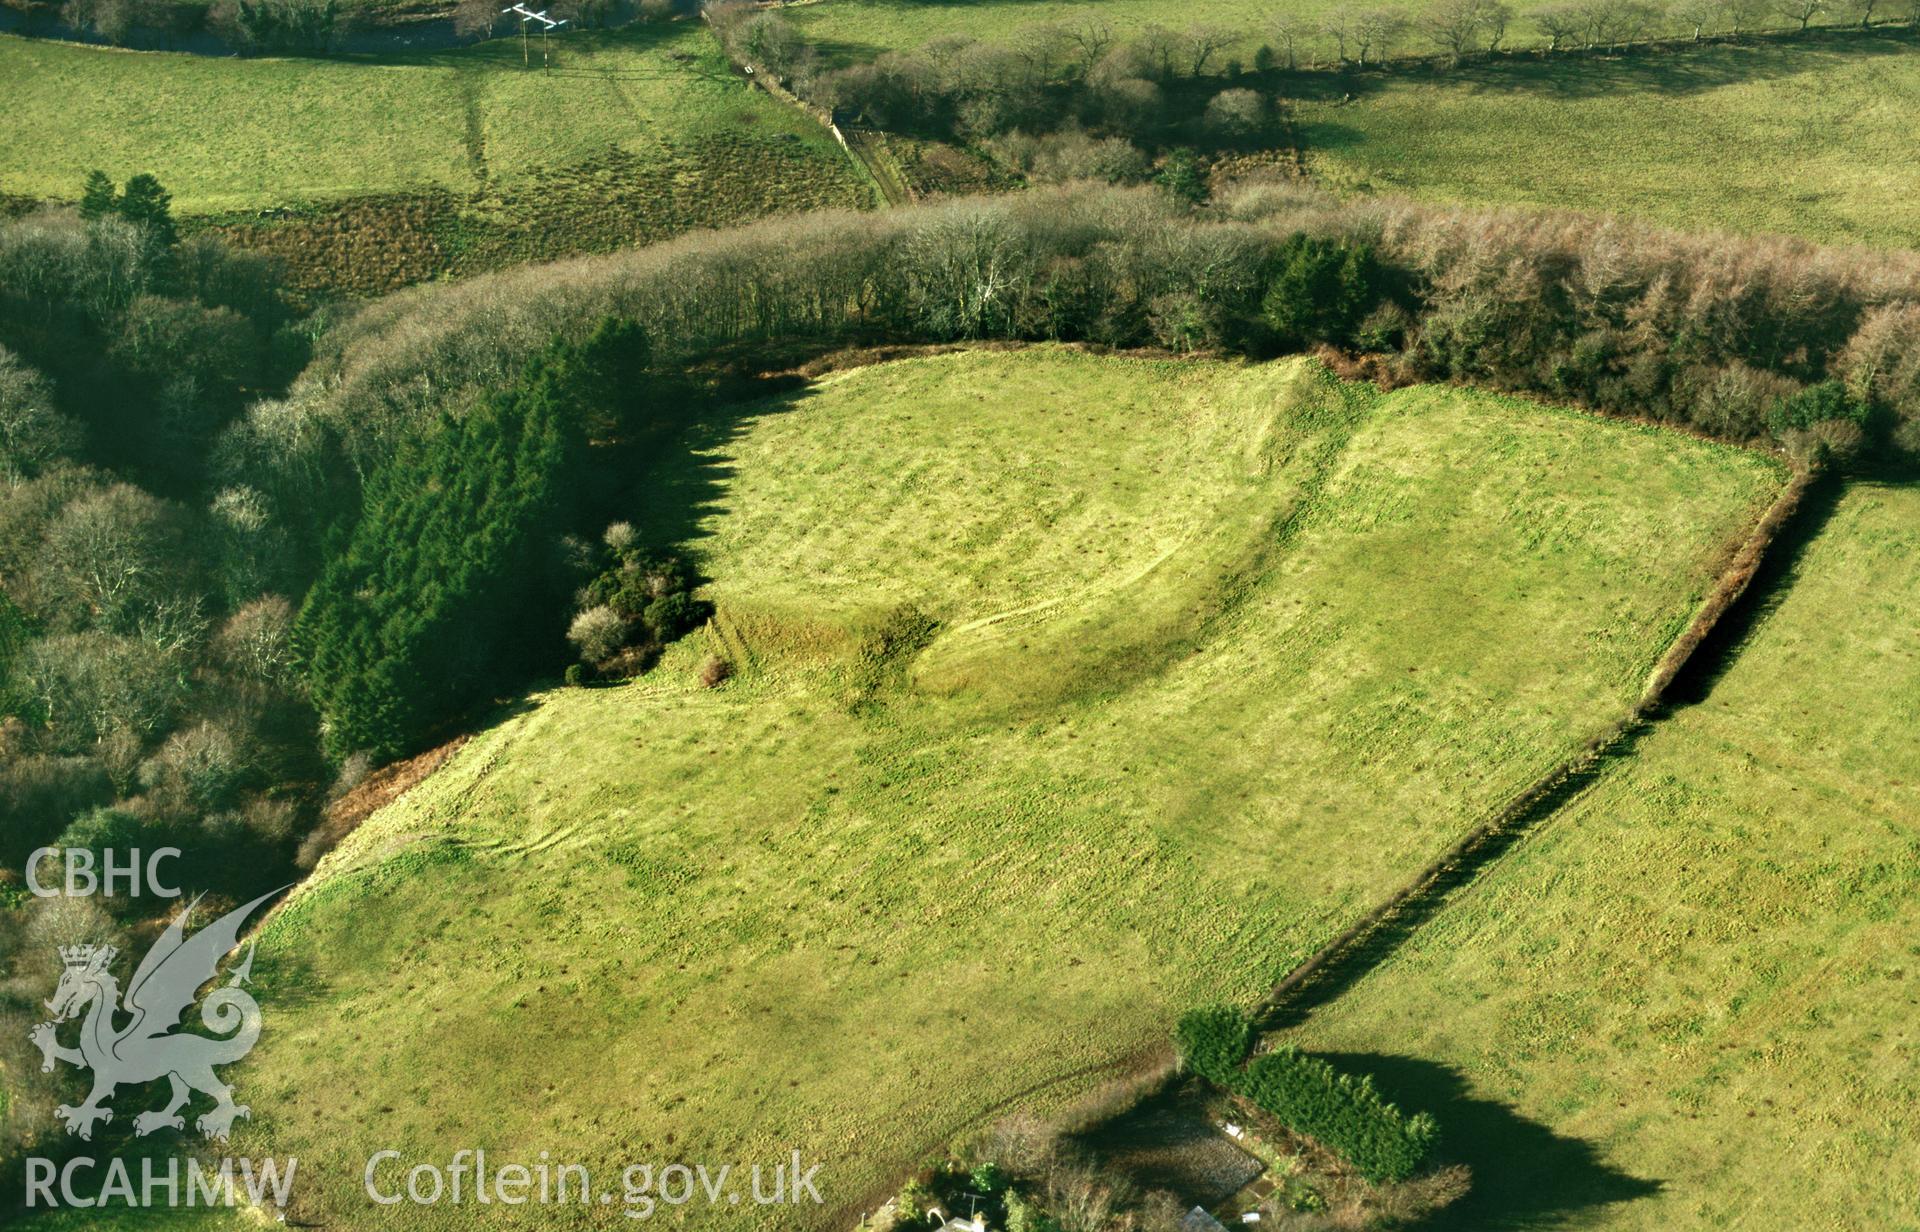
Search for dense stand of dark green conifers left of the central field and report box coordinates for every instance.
[294,320,647,758]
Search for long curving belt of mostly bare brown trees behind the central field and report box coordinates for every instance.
[284,184,1920,487]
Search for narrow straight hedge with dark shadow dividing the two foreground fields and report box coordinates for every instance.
[1256,466,1816,1031]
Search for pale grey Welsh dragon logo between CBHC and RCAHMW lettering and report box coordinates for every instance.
[27,887,284,1142]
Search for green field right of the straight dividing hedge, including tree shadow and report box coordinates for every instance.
[1300,484,1920,1232]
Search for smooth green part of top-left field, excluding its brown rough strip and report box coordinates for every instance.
[0,23,867,213]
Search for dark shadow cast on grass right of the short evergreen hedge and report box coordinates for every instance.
[1315,1054,1661,1232]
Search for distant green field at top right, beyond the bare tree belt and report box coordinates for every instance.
[1296,36,1920,246]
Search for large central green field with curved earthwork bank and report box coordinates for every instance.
[149,349,1782,1230]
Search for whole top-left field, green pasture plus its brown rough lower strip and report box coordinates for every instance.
[0,23,877,292]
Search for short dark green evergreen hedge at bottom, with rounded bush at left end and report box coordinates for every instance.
[1177,1006,1440,1184]
